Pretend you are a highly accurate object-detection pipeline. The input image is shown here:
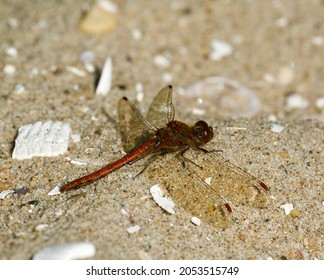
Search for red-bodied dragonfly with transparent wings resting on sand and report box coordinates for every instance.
[60,85,269,228]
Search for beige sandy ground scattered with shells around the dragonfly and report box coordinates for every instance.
[0,0,324,259]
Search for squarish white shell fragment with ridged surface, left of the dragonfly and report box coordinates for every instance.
[12,121,71,159]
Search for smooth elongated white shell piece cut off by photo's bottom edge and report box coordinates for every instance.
[33,242,96,260]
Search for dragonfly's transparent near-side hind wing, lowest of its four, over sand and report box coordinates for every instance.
[147,155,231,229]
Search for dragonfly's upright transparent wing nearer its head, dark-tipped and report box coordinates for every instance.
[147,85,175,128]
